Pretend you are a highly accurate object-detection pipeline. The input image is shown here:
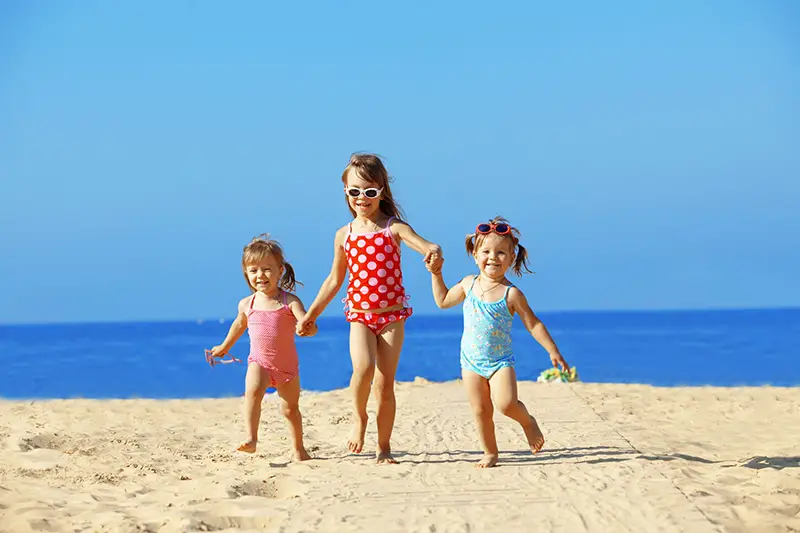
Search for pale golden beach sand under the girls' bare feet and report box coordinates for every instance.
[0,379,800,533]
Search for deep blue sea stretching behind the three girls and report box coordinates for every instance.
[0,309,800,398]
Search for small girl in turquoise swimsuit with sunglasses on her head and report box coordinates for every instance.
[428,217,569,468]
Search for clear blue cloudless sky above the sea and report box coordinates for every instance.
[0,0,800,323]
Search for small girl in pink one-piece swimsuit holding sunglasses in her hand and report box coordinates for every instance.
[211,234,316,461]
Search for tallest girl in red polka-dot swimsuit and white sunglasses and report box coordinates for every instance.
[297,154,442,463]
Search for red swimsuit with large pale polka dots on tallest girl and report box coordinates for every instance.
[343,217,412,333]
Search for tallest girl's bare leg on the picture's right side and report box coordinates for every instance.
[372,320,405,464]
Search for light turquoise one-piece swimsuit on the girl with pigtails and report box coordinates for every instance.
[461,276,514,379]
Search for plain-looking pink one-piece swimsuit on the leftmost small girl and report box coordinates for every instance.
[247,291,299,387]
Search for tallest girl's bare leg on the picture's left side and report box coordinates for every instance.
[347,322,377,453]
